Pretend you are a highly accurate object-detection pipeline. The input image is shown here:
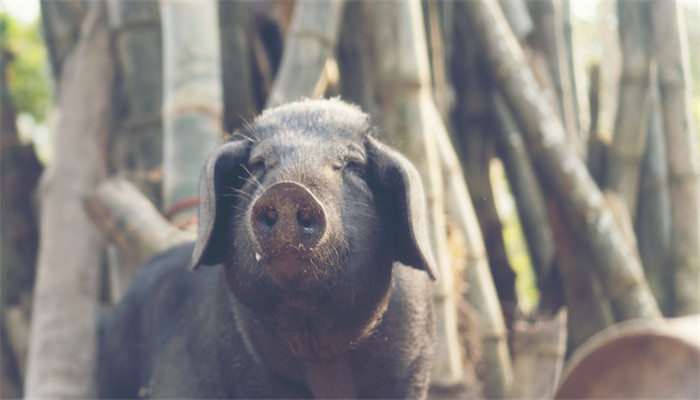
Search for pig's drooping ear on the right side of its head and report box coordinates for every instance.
[367,136,438,280]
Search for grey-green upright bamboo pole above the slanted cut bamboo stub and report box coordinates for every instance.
[106,0,163,205]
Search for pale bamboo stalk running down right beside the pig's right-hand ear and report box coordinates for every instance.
[371,2,463,386]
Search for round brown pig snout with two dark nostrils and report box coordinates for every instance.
[250,182,327,260]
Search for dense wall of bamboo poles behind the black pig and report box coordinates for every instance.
[1,0,700,398]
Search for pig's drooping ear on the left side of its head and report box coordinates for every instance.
[190,140,250,269]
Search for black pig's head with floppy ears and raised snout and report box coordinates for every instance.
[192,100,436,316]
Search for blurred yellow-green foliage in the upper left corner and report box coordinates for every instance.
[0,13,52,121]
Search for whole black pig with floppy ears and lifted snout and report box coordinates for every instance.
[98,100,436,398]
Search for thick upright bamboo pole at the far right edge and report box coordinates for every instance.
[650,1,700,315]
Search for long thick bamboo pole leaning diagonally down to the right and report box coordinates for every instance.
[465,0,660,320]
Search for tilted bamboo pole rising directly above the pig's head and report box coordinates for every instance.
[266,0,344,107]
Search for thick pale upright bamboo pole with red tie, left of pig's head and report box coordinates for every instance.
[160,0,223,226]
